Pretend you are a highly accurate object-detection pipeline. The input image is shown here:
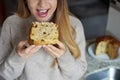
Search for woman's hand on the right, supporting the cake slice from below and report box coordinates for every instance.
[43,41,67,58]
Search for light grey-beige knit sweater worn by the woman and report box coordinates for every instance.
[0,15,87,80]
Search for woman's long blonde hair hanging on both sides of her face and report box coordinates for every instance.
[17,0,80,63]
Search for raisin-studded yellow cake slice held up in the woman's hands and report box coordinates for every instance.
[29,22,58,45]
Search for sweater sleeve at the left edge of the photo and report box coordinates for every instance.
[0,19,25,80]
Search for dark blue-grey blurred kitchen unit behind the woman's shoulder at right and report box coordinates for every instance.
[68,0,109,39]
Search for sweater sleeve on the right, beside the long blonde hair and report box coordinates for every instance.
[58,17,87,80]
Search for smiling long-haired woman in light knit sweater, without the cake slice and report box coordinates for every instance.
[0,0,87,80]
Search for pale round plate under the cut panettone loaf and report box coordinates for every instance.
[88,43,120,62]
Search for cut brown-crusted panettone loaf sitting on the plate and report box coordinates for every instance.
[95,35,120,59]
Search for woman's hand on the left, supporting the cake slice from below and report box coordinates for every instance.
[16,41,41,59]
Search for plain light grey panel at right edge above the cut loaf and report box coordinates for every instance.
[107,6,120,40]
